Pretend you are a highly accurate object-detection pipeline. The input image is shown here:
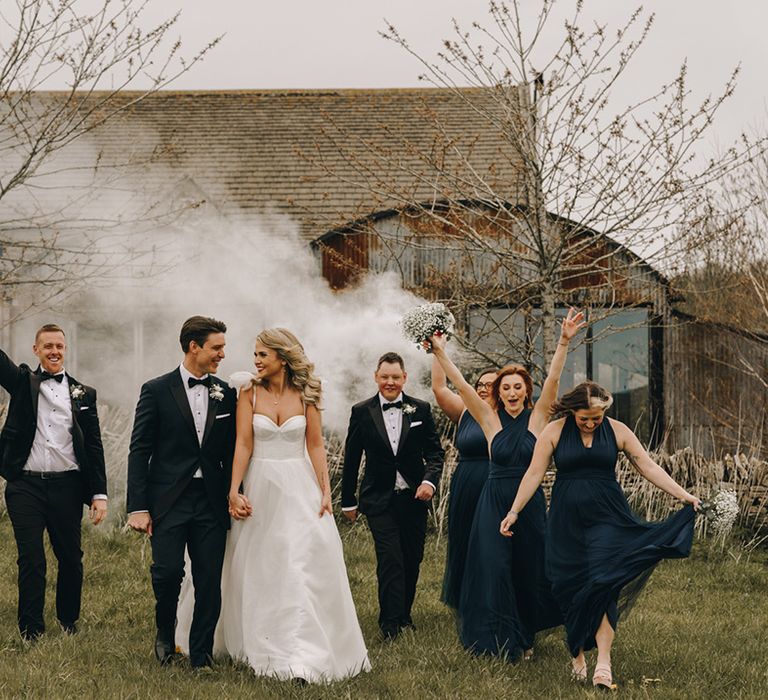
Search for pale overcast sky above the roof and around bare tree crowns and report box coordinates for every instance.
[27,0,768,146]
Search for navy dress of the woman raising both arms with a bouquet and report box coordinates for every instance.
[458,409,562,661]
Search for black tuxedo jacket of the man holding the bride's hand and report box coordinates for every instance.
[127,367,236,528]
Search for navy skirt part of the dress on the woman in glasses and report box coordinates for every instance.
[441,459,488,609]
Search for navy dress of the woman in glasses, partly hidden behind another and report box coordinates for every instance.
[441,411,488,609]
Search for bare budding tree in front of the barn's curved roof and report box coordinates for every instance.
[310,0,764,378]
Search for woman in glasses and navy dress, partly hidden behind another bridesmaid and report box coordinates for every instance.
[432,359,497,610]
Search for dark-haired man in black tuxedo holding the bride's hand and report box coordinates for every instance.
[127,316,235,668]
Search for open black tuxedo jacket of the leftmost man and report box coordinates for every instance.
[0,350,107,504]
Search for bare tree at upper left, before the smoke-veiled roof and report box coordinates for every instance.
[0,0,218,322]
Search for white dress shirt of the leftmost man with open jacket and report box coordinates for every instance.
[24,370,107,500]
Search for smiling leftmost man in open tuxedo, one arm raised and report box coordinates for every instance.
[0,323,107,641]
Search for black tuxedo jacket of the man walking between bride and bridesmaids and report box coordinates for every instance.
[341,394,445,515]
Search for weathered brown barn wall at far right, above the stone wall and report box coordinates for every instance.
[664,315,768,456]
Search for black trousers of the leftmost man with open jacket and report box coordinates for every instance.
[5,471,83,636]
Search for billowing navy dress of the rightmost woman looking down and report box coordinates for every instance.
[544,415,695,657]
